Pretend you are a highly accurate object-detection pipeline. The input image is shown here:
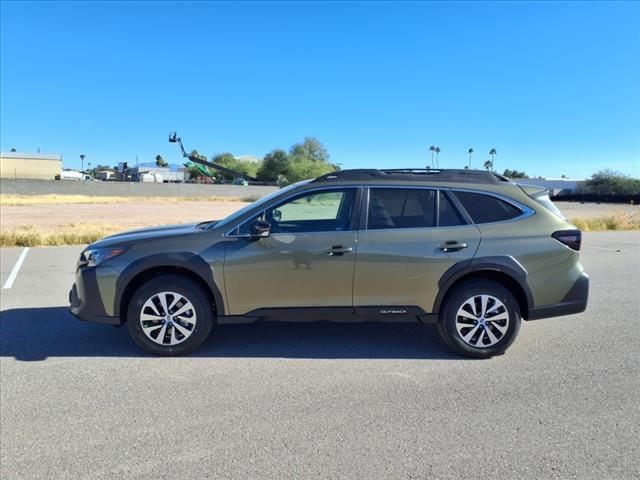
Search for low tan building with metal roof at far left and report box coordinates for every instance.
[0,152,62,180]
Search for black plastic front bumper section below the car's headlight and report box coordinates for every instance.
[69,268,122,325]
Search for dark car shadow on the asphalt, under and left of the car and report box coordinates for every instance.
[0,307,461,361]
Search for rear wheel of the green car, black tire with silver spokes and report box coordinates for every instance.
[438,279,521,358]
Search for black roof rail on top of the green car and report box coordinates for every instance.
[314,168,510,183]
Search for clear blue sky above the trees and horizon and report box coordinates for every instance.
[0,2,640,178]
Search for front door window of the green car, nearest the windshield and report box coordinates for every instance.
[239,189,355,235]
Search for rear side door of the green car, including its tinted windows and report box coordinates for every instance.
[354,187,481,314]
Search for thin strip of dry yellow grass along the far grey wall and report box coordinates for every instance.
[0,194,249,207]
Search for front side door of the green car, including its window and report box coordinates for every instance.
[224,187,362,315]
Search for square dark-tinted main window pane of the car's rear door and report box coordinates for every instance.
[367,188,436,230]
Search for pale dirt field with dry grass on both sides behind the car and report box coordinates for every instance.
[0,194,640,247]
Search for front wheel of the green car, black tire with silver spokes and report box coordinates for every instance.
[127,275,215,356]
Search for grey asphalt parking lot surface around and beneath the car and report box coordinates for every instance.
[0,232,640,480]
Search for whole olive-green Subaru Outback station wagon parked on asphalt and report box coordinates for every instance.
[69,169,589,357]
